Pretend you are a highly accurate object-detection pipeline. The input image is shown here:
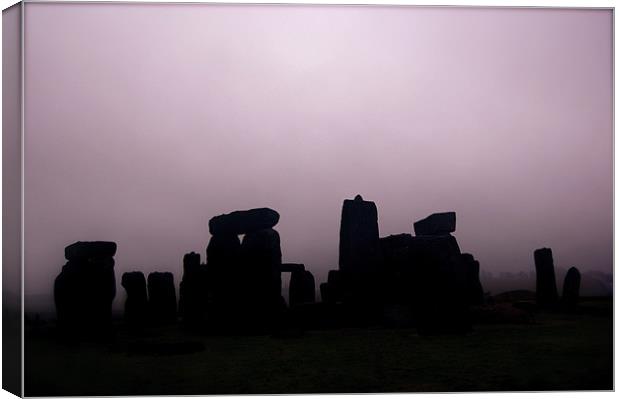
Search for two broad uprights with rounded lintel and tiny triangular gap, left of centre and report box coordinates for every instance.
[202,208,286,331]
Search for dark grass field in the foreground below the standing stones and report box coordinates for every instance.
[25,301,613,396]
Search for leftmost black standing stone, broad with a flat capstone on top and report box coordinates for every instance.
[54,241,116,337]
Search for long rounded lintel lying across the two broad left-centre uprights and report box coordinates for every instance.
[209,208,280,236]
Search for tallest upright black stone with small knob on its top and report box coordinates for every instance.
[339,195,381,272]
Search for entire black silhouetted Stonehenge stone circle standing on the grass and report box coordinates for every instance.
[54,195,581,334]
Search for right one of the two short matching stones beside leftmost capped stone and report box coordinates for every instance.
[147,272,177,322]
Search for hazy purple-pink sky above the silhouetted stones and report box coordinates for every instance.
[25,3,612,314]
